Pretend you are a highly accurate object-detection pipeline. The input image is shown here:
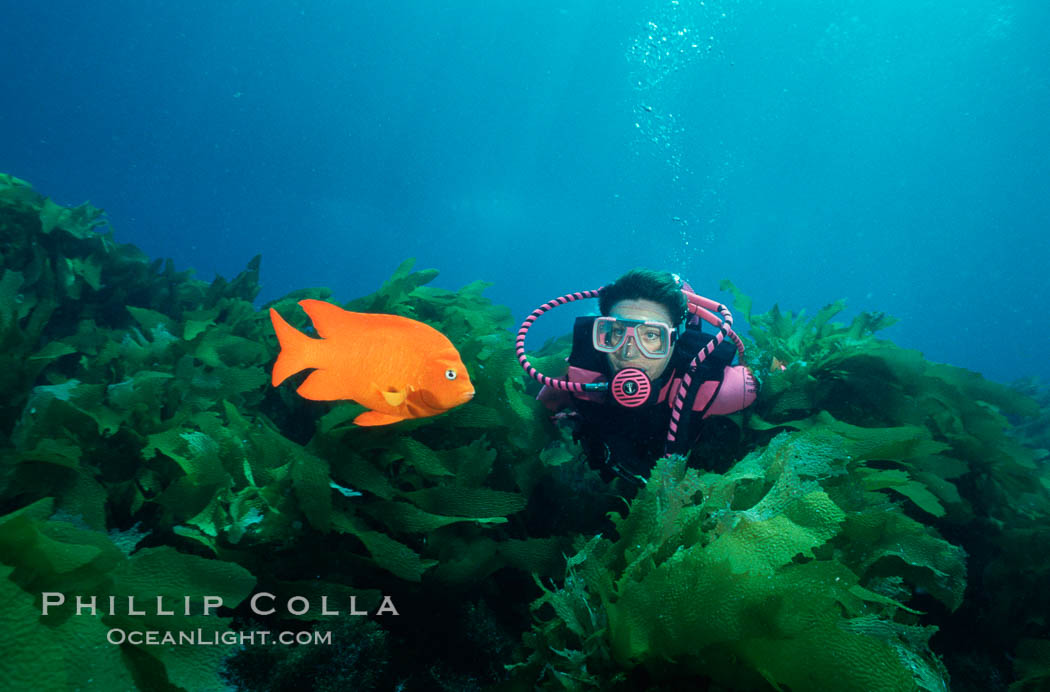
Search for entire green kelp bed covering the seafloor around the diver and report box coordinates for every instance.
[0,176,1050,690]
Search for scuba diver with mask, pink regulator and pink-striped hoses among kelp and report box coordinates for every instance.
[517,269,756,489]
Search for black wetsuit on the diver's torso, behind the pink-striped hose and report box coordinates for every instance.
[569,317,736,483]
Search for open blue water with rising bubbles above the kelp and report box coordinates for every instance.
[0,0,1050,380]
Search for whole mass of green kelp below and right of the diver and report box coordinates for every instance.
[513,285,1050,692]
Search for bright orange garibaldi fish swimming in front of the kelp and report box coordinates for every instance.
[270,300,474,425]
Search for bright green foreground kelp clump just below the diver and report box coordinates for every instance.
[512,441,965,690]
